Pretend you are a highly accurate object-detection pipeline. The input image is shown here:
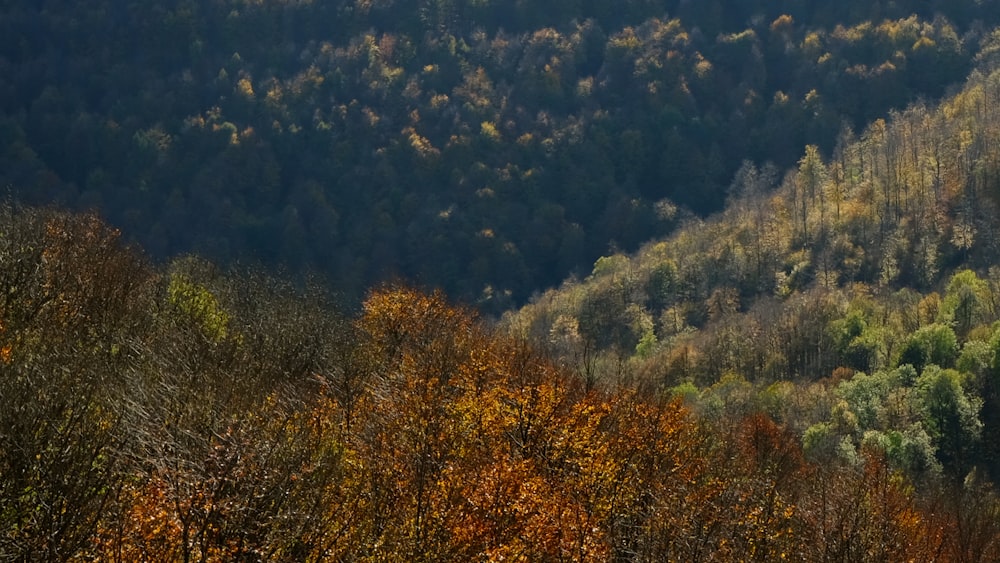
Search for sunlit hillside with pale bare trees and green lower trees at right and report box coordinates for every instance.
[505,60,1000,484]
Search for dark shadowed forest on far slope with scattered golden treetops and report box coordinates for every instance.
[0,0,1000,313]
